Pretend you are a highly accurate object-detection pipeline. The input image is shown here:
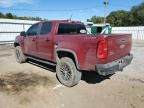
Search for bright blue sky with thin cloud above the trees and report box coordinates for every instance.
[0,0,144,21]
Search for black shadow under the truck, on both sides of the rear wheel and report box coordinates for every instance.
[27,60,112,84]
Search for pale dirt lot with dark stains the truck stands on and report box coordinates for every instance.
[0,44,144,108]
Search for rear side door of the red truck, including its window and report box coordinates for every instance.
[37,22,53,60]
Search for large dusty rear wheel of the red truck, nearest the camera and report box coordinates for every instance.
[56,57,82,87]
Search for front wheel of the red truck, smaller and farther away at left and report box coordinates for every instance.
[15,46,26,63]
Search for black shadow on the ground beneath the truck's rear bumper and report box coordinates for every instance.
[81,71,112,84]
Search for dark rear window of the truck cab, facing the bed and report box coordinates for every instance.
[58,23,86,34]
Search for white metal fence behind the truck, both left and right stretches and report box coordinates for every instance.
[0,19,144,44]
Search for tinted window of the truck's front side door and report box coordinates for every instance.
[27,24,39,36]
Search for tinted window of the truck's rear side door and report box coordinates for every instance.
[40,22,52,35]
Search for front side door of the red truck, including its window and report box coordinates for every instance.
[24,24,39,56]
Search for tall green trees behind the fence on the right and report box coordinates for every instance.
[87,2,144,26]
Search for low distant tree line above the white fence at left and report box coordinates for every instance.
[0,12,47,21]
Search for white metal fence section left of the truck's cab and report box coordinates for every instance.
[0,19,38,44]
